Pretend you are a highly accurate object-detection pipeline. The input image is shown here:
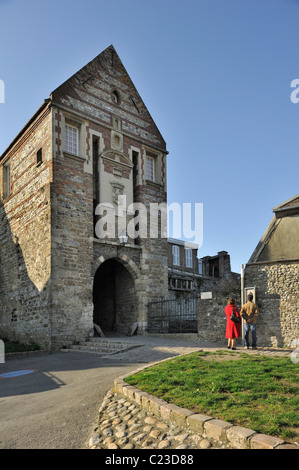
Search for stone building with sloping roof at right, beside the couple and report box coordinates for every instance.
[245,194,299,347]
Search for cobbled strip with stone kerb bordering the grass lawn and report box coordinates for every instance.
[89,361,299,449]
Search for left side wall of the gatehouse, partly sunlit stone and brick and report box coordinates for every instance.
[0,107,52,348]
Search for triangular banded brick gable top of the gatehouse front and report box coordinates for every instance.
[50,45,166,151]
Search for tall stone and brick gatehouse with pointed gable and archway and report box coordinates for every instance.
[0,46,168,350]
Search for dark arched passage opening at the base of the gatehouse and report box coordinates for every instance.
[93,258,138,334]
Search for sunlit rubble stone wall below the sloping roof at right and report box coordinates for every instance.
[245,261,299,347]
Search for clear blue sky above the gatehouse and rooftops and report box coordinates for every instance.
[0,0,299,272]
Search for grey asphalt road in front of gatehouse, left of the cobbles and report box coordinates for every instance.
[0,352,140,449]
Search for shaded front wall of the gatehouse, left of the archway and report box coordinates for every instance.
[51,110,93,349]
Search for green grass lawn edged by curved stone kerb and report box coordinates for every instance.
[125,351,299,443]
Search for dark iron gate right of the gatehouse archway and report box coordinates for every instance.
[147,297,198,333]
